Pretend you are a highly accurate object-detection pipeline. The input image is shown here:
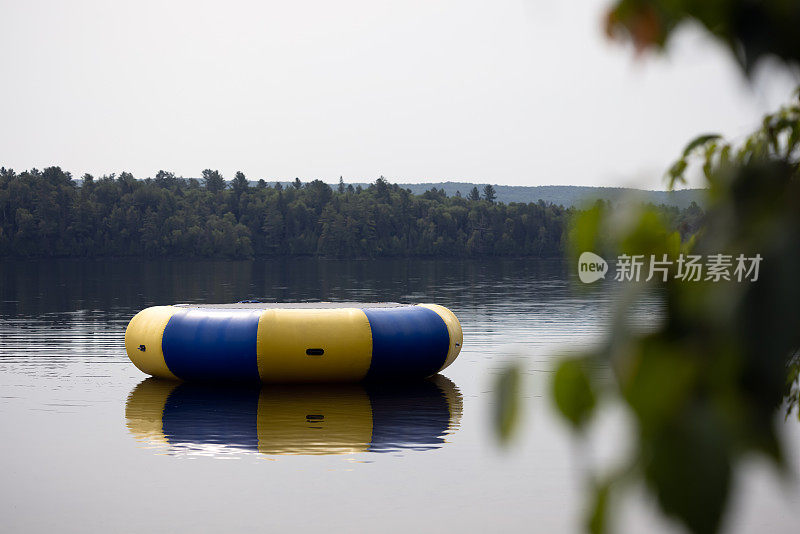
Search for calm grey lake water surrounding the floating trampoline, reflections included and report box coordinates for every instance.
[0,259,800,533]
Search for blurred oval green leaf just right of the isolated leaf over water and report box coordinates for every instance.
[553,359,596,429]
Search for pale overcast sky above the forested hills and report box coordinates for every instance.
[0,0,797,188]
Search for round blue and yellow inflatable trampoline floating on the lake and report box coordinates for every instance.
[125,302,463,383]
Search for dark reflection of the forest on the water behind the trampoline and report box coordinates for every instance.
[0,258,580,323]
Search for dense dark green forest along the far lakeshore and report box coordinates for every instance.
[0,167,703,258]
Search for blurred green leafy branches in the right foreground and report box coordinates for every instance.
[496,0,800,533]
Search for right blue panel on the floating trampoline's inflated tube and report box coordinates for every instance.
[364,306,450,380]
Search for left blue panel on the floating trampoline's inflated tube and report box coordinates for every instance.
[161,309,261,382]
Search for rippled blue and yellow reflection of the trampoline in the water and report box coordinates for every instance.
[125,375,462,455]
